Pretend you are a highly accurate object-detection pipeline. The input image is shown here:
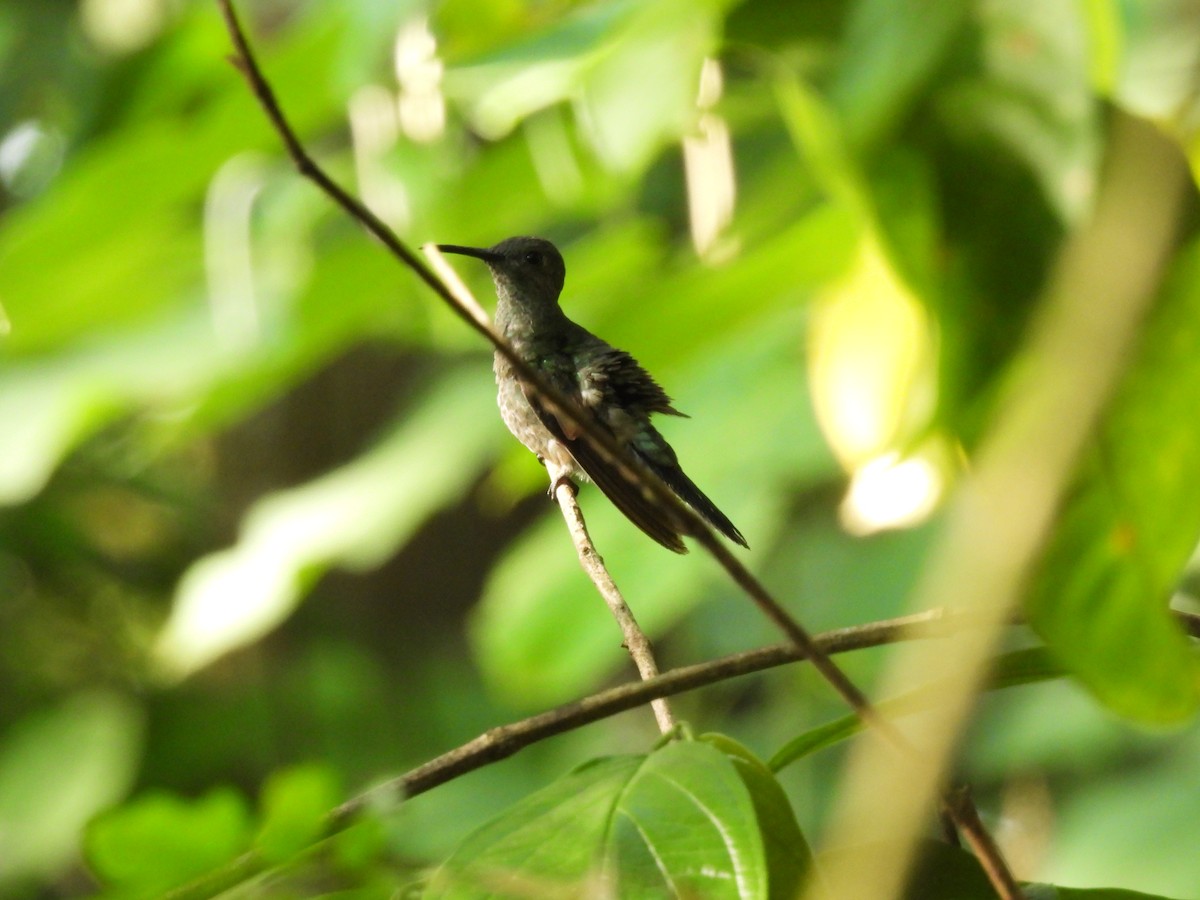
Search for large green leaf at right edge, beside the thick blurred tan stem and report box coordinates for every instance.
[1026,244,1200,722]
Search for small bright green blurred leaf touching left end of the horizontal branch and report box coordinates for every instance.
[254,764,342,863]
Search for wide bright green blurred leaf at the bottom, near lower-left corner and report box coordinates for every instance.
[86,788,251,896]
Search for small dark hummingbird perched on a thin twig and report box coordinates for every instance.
[438,238,750,553]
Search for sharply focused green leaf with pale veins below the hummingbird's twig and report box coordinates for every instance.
[427,742,767,898]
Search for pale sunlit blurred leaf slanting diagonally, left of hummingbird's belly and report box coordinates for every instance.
[157,372,503,676]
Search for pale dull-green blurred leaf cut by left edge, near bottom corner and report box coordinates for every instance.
[0,690,143,893]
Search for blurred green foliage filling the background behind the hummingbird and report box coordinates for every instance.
[0,0,1200,898]
